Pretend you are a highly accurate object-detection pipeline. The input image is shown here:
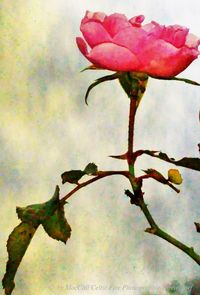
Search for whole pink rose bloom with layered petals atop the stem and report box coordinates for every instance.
[76,11,200,78]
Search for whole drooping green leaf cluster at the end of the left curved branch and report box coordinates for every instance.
[2,186,71,295]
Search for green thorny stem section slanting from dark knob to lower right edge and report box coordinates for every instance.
[139,198,200,265]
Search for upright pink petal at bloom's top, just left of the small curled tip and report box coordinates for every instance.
[103,13,131,37]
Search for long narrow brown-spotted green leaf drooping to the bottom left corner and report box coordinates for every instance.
[2,222,37,295]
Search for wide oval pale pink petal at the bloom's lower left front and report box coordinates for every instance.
[87,43,139,71]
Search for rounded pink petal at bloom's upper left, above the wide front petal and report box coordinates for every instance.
[80,21,111,48]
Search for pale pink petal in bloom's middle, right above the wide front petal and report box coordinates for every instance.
[113,26,148,53]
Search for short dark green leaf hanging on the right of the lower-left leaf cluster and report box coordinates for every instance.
[42,205,71,244]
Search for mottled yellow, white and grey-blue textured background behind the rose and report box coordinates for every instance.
[0,0,200,295]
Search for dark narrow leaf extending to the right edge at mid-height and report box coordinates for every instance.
[143,150,200,171]
